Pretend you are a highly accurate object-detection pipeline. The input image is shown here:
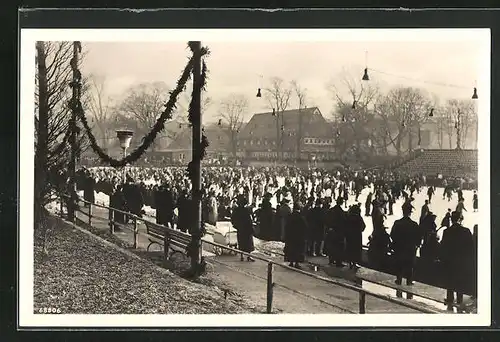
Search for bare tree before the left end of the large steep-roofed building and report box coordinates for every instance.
[264,77,292,159]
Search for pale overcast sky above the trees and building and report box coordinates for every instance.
[82,40,481,123]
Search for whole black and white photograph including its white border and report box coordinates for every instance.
[19,29,491,327]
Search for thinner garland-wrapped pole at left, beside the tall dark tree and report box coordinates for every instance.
[68,41,81,222]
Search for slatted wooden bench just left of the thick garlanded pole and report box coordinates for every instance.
[144,221,191,259]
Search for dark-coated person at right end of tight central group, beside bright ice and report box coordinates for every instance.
[346,205,366,269]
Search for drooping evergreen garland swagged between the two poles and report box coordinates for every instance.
[70,42,208,167]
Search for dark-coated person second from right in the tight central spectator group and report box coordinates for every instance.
[325,197,346,267]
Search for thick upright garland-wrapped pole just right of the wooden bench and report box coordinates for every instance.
[190,41,202,273]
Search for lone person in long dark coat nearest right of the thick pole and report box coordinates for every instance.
[231,195,255,261]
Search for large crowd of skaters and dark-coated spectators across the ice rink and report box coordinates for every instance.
[73,166,478,302]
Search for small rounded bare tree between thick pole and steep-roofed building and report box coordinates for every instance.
[219,94,248,158]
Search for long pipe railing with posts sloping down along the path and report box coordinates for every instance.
[61,195,444,314]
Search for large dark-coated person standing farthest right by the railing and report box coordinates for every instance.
[440,211,474,304]
